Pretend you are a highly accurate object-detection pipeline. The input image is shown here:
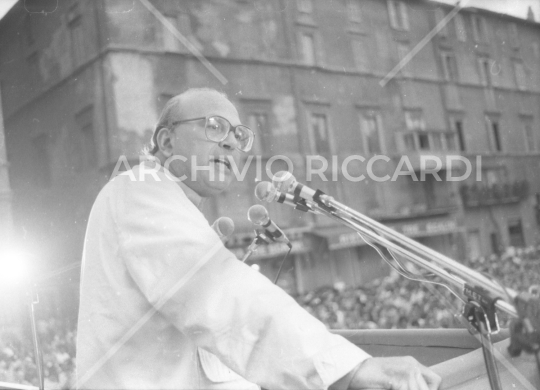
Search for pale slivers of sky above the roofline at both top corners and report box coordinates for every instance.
[0,0,540,21]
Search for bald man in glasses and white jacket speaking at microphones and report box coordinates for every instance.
[77,89,440,390]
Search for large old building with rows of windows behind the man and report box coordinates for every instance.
[0,0,540,314]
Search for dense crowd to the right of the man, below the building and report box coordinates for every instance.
[297,247,540,329]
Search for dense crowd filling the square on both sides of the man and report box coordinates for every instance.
[0,247,540,389]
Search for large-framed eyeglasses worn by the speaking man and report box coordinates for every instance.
[171,115,255,152]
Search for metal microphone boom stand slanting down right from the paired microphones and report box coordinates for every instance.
[294,191,528,390]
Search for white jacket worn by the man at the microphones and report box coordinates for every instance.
[77,165,369,389]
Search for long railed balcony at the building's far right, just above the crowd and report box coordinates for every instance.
[460,180,529,207]
